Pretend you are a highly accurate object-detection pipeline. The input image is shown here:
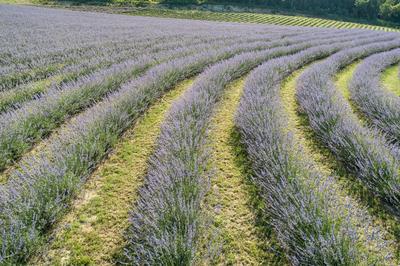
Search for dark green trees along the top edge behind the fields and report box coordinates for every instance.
[34,0,400,23]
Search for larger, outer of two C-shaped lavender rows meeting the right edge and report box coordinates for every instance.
[297,35,400,217]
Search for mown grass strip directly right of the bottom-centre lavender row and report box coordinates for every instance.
[206,78,284,265]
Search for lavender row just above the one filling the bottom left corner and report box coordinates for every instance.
[0,32,288,170]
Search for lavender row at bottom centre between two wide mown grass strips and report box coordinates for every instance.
[125,30,382,265]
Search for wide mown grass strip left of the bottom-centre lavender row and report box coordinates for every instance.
[33,79,193,265]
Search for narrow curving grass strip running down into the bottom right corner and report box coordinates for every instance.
[281,65,398,265]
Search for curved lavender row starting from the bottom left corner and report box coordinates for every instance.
[0,13,318,262]
